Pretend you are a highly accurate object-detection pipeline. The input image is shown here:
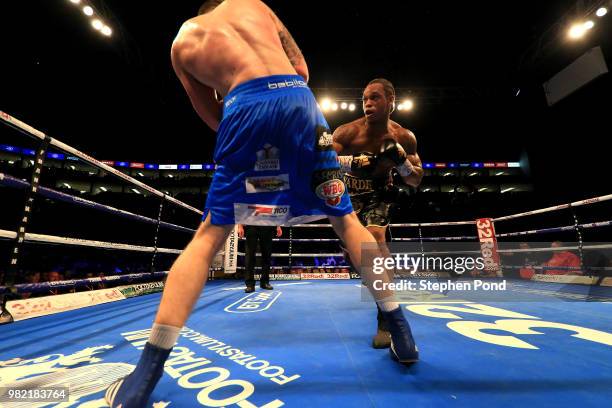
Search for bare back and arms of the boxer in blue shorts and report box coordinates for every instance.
[172,0,308,130]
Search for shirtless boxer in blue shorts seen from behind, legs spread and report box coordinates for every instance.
[106,0,418,408]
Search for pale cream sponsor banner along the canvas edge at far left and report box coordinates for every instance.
[6,288,125,321]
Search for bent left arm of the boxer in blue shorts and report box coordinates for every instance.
[171,41,223,132]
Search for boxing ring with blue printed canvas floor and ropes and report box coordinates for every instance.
[0,112,612,408]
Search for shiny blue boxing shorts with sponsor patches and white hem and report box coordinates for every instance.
[203,75,353,225]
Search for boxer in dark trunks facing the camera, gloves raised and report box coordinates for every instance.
[333,78,423,348]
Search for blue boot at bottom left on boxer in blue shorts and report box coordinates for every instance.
[104,343,172,408]
